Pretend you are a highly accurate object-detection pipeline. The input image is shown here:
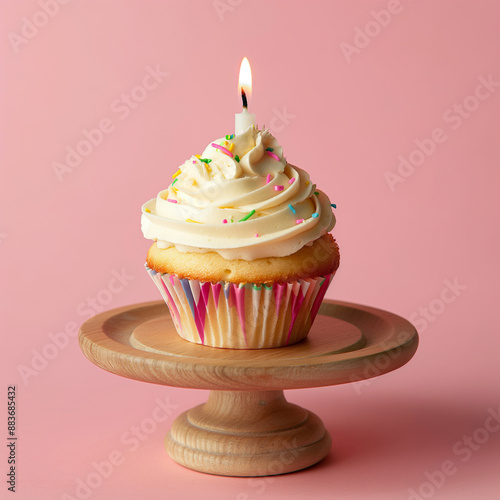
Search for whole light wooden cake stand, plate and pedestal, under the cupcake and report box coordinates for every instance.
[80,300,418,476]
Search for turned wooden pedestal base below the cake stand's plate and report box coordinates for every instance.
[165,391,331,476]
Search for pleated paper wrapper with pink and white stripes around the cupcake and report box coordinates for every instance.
[146,265,335,349]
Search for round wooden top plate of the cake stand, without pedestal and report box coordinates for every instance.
[80,300,418,391]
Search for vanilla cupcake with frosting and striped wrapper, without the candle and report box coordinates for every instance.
[142,126,339,349]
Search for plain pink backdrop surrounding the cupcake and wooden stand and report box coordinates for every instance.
[0,0,500,500]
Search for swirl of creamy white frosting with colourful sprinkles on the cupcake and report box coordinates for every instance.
[141,127,335,260]
